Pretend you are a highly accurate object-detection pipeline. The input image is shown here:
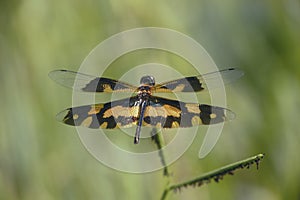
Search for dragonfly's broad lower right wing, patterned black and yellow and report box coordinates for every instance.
[144,96,235,128]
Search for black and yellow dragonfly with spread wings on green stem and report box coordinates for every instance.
[49,68,243,144]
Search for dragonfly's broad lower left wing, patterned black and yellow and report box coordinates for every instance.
[56,97,139,129]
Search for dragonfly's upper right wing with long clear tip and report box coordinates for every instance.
[153,68,244,92]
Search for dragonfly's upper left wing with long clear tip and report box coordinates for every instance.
[49,70,136,92]
